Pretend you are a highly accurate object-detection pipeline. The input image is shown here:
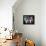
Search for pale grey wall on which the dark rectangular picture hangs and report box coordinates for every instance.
[13,0,41,46]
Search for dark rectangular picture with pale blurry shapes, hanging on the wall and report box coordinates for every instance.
[23,15,35,24]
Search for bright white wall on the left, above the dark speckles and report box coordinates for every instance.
[0,0,16,29]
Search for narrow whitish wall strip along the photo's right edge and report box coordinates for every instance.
[41,0,46,46]
